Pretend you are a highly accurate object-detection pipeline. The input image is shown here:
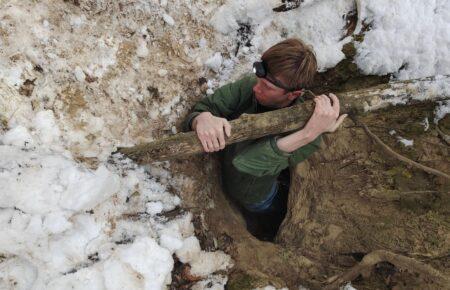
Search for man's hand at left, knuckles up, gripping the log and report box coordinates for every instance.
[192,112,231,152]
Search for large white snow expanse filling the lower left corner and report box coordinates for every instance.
[0,106,232,289]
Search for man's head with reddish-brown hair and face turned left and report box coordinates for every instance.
[253,38,317,108]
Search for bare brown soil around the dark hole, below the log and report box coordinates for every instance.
[172,103,450,289]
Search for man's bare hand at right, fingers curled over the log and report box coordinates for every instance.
[304,94,347,136]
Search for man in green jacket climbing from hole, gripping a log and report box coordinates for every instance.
[186,39,345,218]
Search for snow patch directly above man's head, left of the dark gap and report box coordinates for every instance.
[211,0,354,70]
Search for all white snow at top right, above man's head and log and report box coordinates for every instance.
[211,0,450,83]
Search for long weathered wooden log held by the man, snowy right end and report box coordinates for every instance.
[116,76,450,163]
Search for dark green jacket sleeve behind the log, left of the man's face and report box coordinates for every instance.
[183,75,254,131]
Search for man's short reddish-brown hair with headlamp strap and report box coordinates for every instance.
[261,38,317,89]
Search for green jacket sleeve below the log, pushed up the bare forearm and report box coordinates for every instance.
[233,136,321,177]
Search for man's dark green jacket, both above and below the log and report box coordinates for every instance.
[184,75,321,206]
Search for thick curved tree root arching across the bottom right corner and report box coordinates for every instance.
[324,250,450,290]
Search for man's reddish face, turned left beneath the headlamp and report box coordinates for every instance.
[253,78,295,108]
